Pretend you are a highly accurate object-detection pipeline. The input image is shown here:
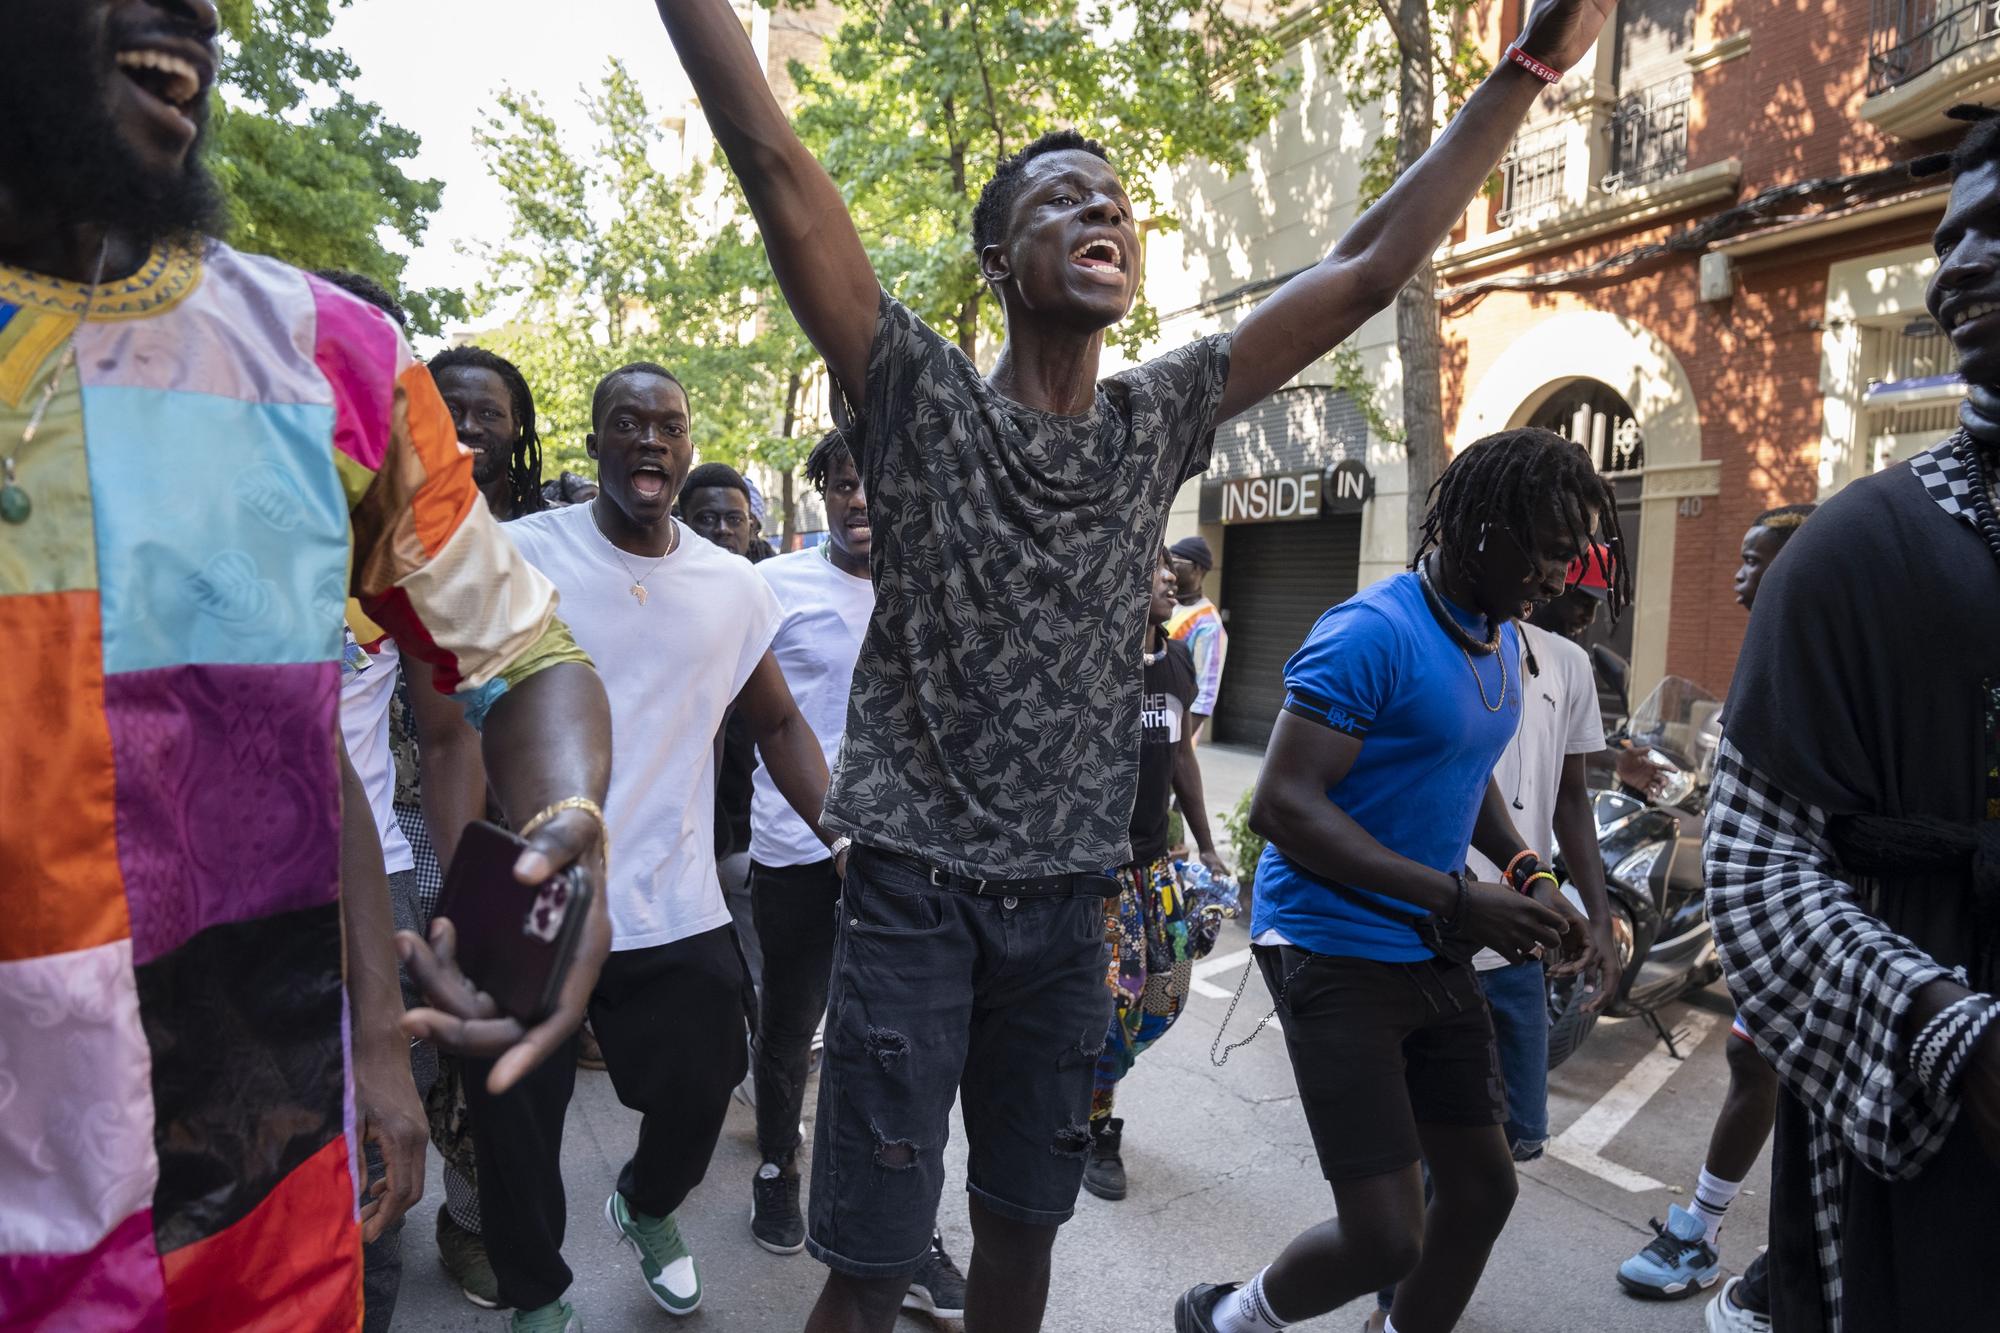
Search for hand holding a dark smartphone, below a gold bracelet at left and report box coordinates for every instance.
[396,811,612,1097]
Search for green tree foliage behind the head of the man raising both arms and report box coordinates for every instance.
[790,0,1292,354]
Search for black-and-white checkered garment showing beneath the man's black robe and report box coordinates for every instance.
[1702,430,2000,1333]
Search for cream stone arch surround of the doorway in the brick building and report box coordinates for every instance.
[1456,310,1720,699]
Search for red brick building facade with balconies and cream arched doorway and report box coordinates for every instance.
[1438,0,1968,695]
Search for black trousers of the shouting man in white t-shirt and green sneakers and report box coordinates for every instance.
[466,927,750,1309]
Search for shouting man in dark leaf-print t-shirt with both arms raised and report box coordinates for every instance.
[658,0,1610,1333]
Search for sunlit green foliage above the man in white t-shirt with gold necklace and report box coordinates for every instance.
[474,60,818,498]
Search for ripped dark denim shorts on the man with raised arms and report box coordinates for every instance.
[806,847,1112,1277]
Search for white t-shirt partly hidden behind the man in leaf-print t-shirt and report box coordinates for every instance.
[750,546,874,865]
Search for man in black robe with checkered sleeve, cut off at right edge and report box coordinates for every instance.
[1704,110,2000,1333]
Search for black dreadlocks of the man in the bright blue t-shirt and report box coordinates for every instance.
[1410,426,1632,622]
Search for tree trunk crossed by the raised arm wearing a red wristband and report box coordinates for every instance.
[1396,0,1452,554]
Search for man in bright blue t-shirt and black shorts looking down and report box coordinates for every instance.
[1174,428,1630,1333]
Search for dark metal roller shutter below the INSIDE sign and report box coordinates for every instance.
[1216,514,1362,745]
